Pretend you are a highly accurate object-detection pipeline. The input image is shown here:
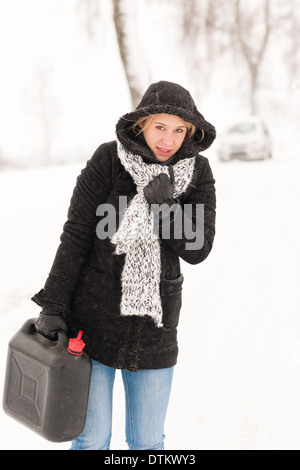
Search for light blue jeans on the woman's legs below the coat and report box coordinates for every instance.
[71,361,174,450]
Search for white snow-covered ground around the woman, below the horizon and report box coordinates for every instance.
[0,151,300,450]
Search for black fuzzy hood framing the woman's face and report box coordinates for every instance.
[116,81,216,163]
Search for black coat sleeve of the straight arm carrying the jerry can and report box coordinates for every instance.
[31,144,112,314]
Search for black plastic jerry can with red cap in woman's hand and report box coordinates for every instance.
[3,319,91,442]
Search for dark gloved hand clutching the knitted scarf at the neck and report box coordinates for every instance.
[144,165,175,206]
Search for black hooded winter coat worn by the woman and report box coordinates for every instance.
[32,82,216,371]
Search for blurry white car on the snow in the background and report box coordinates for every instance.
[218,116,272,162]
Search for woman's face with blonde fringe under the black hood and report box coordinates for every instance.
[143,114,187,162]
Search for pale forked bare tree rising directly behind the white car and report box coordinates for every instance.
[235,0,271,114]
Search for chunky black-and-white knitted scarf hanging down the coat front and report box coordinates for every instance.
[111,140,195,327]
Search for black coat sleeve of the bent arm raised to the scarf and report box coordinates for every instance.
[160,157,216,264]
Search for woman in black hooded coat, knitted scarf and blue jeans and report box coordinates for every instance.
[32,81,215,450]
